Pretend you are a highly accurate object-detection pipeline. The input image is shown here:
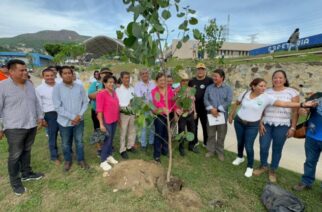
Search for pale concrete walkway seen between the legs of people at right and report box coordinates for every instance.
[198,123,322,180]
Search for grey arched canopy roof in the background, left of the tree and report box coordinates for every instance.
[84,35,124,58]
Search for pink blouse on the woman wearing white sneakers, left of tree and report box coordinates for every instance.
[96,89,120,124]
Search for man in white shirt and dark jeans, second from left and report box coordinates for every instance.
[36,68,60,165]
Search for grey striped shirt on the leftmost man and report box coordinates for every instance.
[0,78,43,129]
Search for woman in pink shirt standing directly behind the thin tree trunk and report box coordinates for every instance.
[151,73,176,162]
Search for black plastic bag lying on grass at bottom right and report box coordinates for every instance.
[261,183,305,212]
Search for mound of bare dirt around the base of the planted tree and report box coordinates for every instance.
[107,160,202,211]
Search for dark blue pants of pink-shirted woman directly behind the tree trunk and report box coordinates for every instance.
[153,115,168,159]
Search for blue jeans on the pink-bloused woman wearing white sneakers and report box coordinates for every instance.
[101,122,117,162]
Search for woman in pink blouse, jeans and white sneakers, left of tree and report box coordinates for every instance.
[96,75,120,171]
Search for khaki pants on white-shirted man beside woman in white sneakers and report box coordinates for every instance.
[120,113,136,153]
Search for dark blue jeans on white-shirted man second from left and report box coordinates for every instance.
[44,111,59,160]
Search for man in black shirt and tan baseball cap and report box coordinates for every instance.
[188,63,213,152]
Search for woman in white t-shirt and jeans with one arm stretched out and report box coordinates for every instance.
[228,78,316,177]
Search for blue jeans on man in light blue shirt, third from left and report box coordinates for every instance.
[59,121,84,162]
